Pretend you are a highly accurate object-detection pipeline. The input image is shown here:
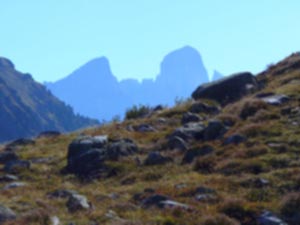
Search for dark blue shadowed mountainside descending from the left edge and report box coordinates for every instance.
[0,58,97,142]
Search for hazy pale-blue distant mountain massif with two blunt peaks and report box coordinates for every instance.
[45,46,209,120]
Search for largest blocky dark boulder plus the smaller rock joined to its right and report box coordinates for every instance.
[63,136,138,179]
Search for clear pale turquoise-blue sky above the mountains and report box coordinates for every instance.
[0,0,300,81]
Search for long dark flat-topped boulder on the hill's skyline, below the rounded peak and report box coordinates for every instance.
[192,72,258,105]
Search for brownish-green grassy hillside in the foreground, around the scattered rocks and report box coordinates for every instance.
[0,54,300,225]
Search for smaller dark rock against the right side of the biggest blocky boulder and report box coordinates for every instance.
[107,139,138,160]
